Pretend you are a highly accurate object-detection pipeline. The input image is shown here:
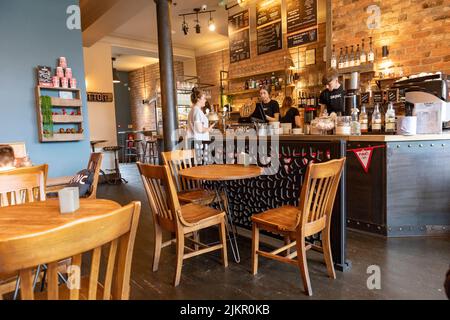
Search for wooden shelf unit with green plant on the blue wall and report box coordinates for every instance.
[36,86,84,142]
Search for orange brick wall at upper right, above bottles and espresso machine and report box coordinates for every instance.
[332,0,450,75]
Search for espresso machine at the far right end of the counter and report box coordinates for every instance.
[391,72,450,133]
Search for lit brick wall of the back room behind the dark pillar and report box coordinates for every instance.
[129,62,184,130]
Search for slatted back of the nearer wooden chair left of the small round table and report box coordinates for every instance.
[138,163,190,232]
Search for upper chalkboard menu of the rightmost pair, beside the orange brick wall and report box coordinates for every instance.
[286,0,317,33]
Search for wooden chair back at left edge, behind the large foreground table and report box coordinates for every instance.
[0,164,48,207]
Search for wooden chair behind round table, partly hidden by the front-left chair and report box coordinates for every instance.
[162,150,216,205]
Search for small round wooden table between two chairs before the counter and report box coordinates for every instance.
[179,164,264,263]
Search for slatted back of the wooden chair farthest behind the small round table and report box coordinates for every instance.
[162,149,201,192]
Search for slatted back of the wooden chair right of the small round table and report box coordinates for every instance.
[296,158,345,236]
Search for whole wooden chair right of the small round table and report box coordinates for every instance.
[252,158,345,295]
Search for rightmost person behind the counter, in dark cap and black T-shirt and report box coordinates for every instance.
[319,69,345,115]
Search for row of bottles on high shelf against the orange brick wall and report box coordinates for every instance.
[331,37,375,69]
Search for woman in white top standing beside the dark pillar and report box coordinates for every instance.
[187,88,215,141]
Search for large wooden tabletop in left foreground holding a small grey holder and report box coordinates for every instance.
[0,199,121,242]
